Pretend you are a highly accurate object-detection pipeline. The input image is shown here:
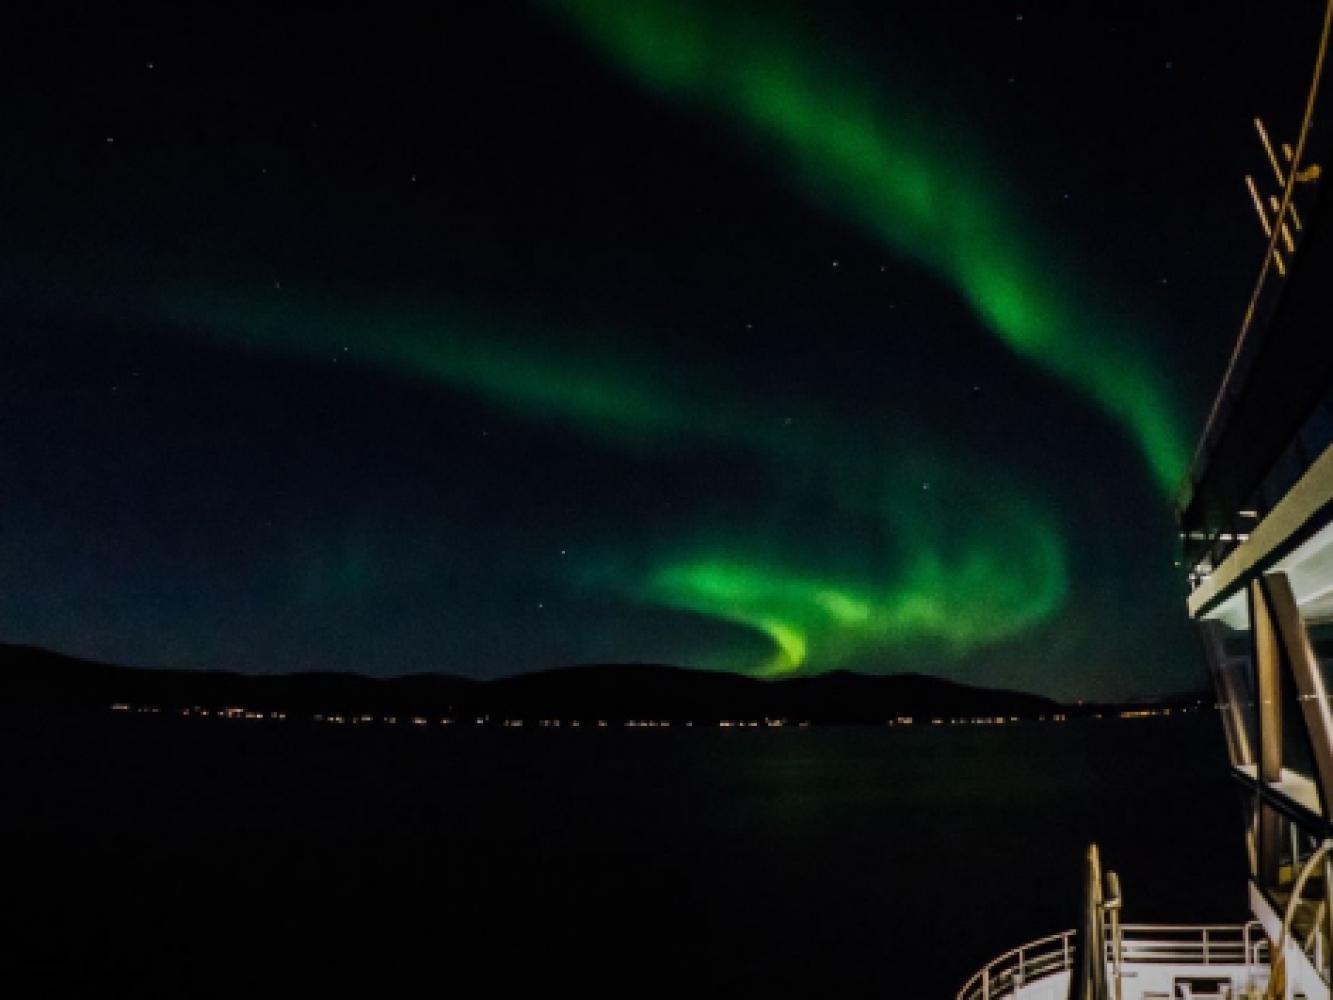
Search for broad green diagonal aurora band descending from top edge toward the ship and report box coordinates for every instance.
[549,0,1188,491]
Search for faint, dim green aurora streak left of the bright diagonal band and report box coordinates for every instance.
[166,284,885,464]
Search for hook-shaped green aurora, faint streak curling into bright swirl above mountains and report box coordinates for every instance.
[157,287,1066,675]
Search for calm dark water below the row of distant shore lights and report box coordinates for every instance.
[0,712,1245,997]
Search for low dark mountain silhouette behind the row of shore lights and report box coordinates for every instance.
[0,645,1066,723]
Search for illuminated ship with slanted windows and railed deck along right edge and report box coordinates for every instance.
[956,0,1333,1000]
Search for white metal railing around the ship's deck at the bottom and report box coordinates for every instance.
[956,920,1268,1000]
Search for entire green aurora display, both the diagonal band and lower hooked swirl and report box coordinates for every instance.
[143,0,1185,676]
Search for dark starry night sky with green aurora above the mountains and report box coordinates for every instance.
[0,0,1318,697]
